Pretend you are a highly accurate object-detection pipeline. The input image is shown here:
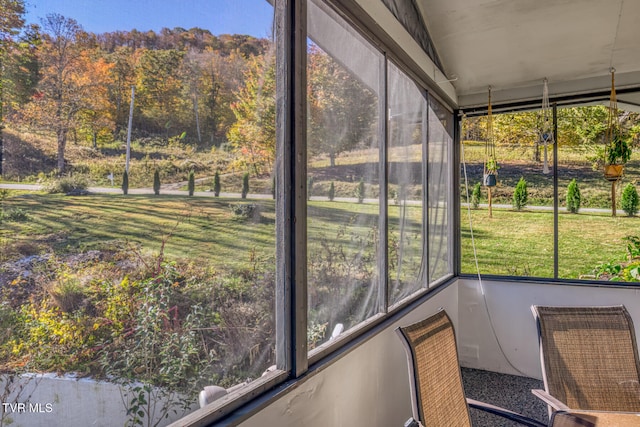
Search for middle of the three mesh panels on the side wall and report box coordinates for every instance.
[387,63,427,305]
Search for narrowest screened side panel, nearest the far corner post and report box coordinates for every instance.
[427,98,453,283]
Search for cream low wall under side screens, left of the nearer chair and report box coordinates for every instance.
[241,283,458,427]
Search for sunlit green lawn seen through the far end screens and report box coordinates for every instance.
[461,208,640,279]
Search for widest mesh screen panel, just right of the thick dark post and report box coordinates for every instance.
[307,3,384,350]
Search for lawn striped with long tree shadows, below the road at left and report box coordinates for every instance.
[0,194,275,266]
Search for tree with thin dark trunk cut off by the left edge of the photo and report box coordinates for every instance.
[0,0,25,176]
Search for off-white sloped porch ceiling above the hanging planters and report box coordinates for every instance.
[415,0,640,108]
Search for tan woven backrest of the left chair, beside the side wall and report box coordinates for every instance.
[396,309,471,427]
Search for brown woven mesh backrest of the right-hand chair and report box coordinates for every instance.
[532,305,640,412]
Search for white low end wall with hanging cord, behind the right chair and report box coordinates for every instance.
[456,279,640,379]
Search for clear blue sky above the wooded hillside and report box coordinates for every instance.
[25,0,273,37]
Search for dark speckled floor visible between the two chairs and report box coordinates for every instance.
[462,368,548,427]
